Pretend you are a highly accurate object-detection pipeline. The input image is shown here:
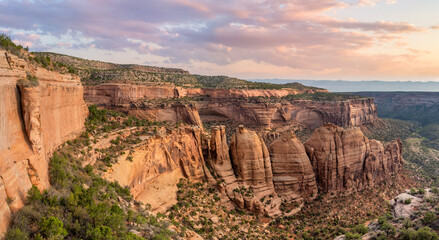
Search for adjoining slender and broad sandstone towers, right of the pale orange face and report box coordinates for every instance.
[210,126,281,216]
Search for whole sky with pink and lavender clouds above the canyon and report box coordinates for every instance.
[0,0,439,81]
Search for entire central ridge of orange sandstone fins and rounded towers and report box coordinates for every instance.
[99,124,402,216]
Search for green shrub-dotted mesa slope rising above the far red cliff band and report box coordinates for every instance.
[32,52,324,90]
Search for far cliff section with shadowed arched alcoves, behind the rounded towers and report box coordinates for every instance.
[198,98,377,129]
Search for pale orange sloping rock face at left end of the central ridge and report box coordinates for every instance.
[104,127,205,211]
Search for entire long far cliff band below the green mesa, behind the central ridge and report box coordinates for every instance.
[84,84,377,129]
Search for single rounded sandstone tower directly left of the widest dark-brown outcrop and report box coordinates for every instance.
[269,130,317,202]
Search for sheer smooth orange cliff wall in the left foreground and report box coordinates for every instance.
[0,51,87,236]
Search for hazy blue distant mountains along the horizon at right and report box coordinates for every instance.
[251,79,439,92]
